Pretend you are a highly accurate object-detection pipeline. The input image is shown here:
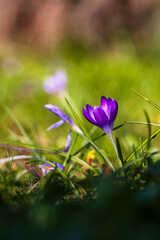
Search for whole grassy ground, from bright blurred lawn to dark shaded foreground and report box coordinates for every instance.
[0,47,160,239]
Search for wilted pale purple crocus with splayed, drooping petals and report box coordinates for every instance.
[44,104,82,152]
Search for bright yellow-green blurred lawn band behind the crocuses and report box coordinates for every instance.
[0,49,160,148]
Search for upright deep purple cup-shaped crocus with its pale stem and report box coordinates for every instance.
[83,96,118,156]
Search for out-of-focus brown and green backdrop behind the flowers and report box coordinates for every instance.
[0,0,160,154]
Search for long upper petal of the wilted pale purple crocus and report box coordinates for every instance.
[44,104,74,126]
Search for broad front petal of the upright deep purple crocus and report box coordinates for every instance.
[93,106,109,129]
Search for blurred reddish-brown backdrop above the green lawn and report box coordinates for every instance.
[0,0,160,49]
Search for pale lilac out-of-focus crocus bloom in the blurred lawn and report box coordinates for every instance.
[43,70,67,94]
